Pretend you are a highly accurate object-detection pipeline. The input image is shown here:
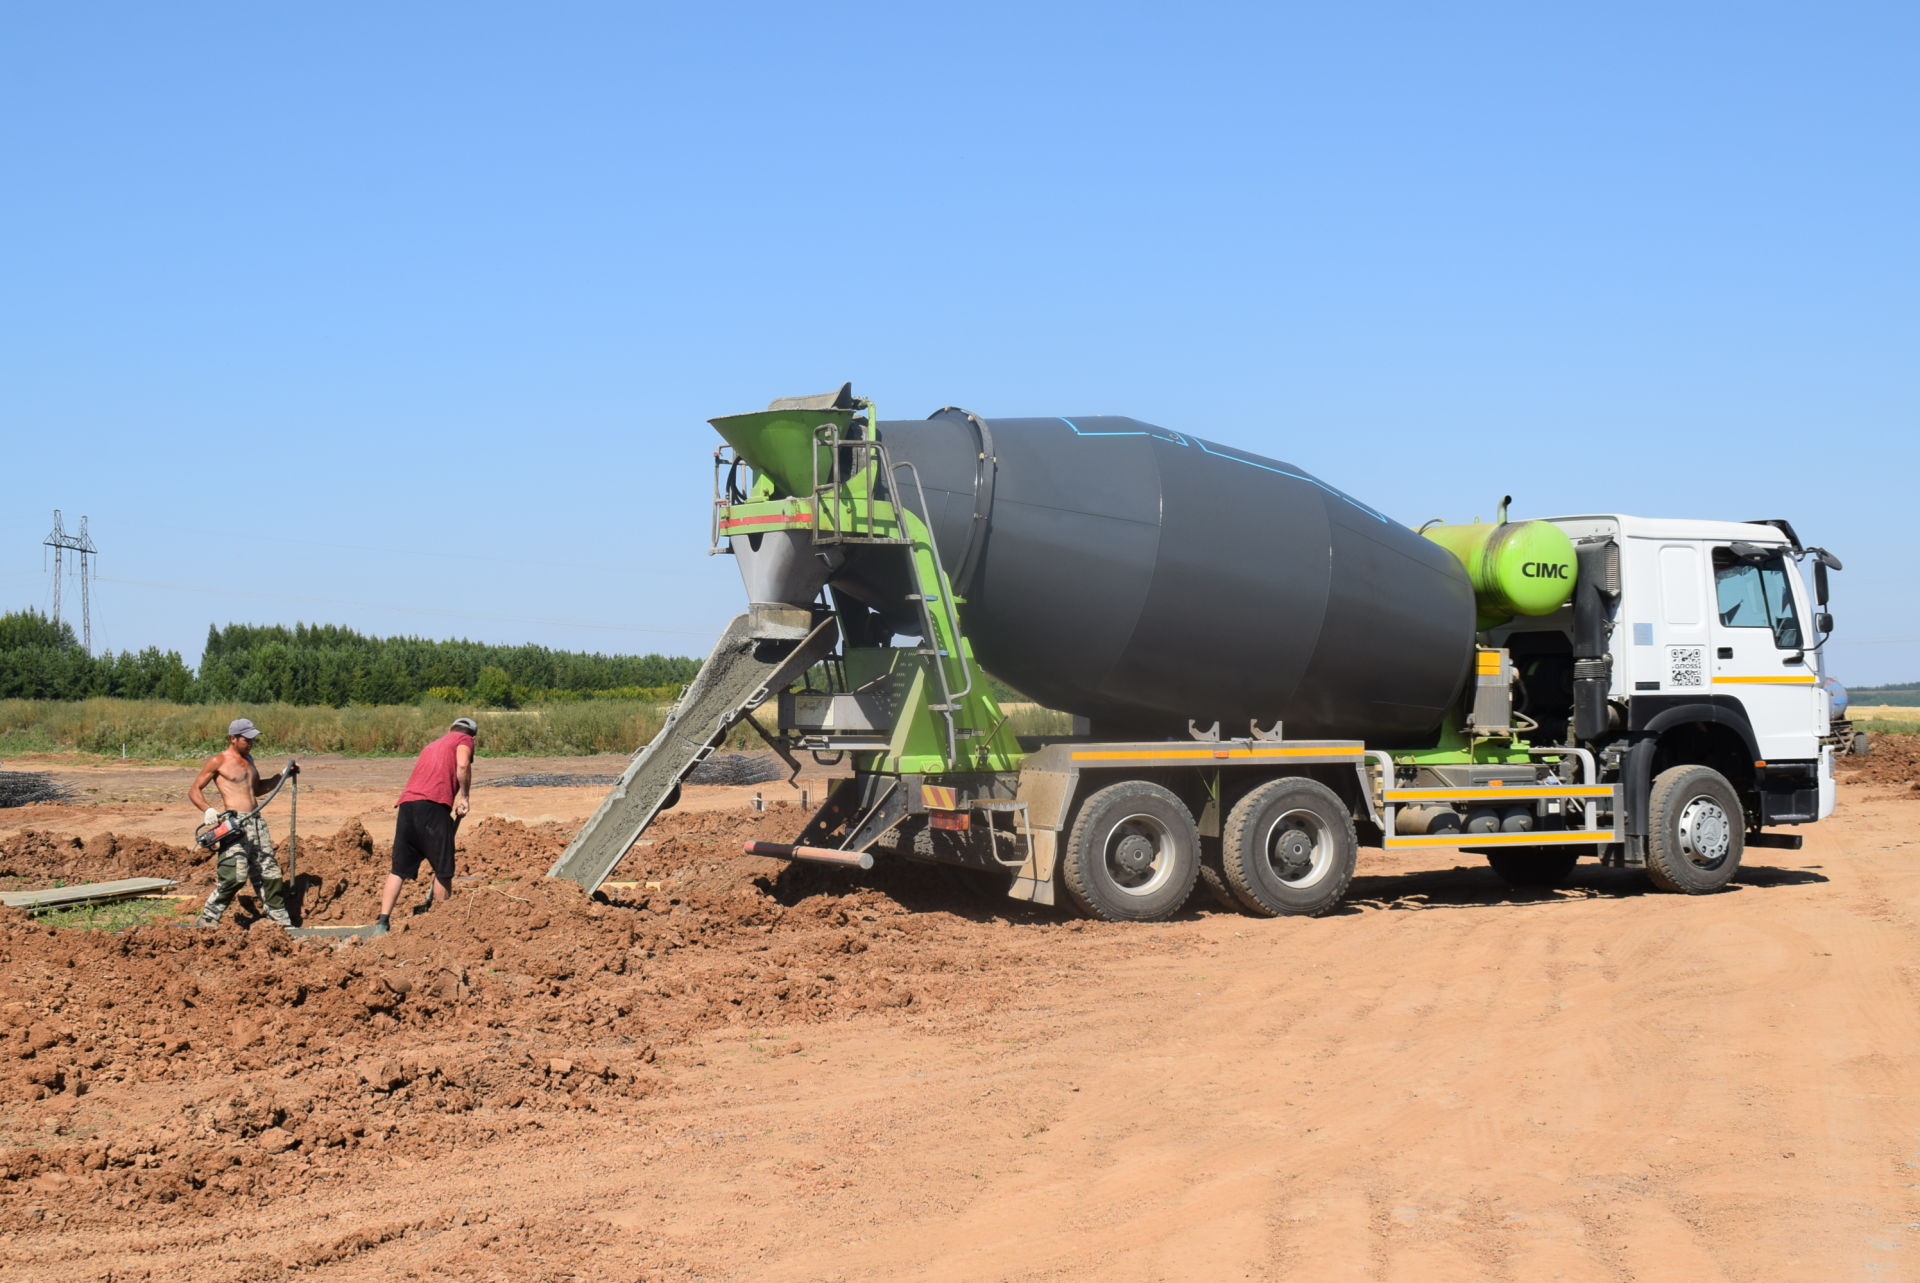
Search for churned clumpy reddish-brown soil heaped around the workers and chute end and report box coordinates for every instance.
[0,807,1079,1233]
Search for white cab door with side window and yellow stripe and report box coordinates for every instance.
[1709,545,1826,761]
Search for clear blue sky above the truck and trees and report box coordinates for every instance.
[0,2,1920,684]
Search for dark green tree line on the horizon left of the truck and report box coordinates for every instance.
[0,609,699,709]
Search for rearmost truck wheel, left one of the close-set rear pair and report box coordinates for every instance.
[1062,780,1200,922]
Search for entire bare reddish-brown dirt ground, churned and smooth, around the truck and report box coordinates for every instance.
[0,738,1920,1283]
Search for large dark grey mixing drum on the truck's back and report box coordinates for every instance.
[829,409,1475,747]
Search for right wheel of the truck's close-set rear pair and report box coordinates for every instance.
[1219,778,1359,918]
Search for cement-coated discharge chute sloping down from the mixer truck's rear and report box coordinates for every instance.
[547,615,837,891]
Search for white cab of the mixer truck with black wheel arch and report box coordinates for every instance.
[1503,513,1843,862]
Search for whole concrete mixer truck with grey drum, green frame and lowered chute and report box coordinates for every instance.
[553,386,1851,920]
